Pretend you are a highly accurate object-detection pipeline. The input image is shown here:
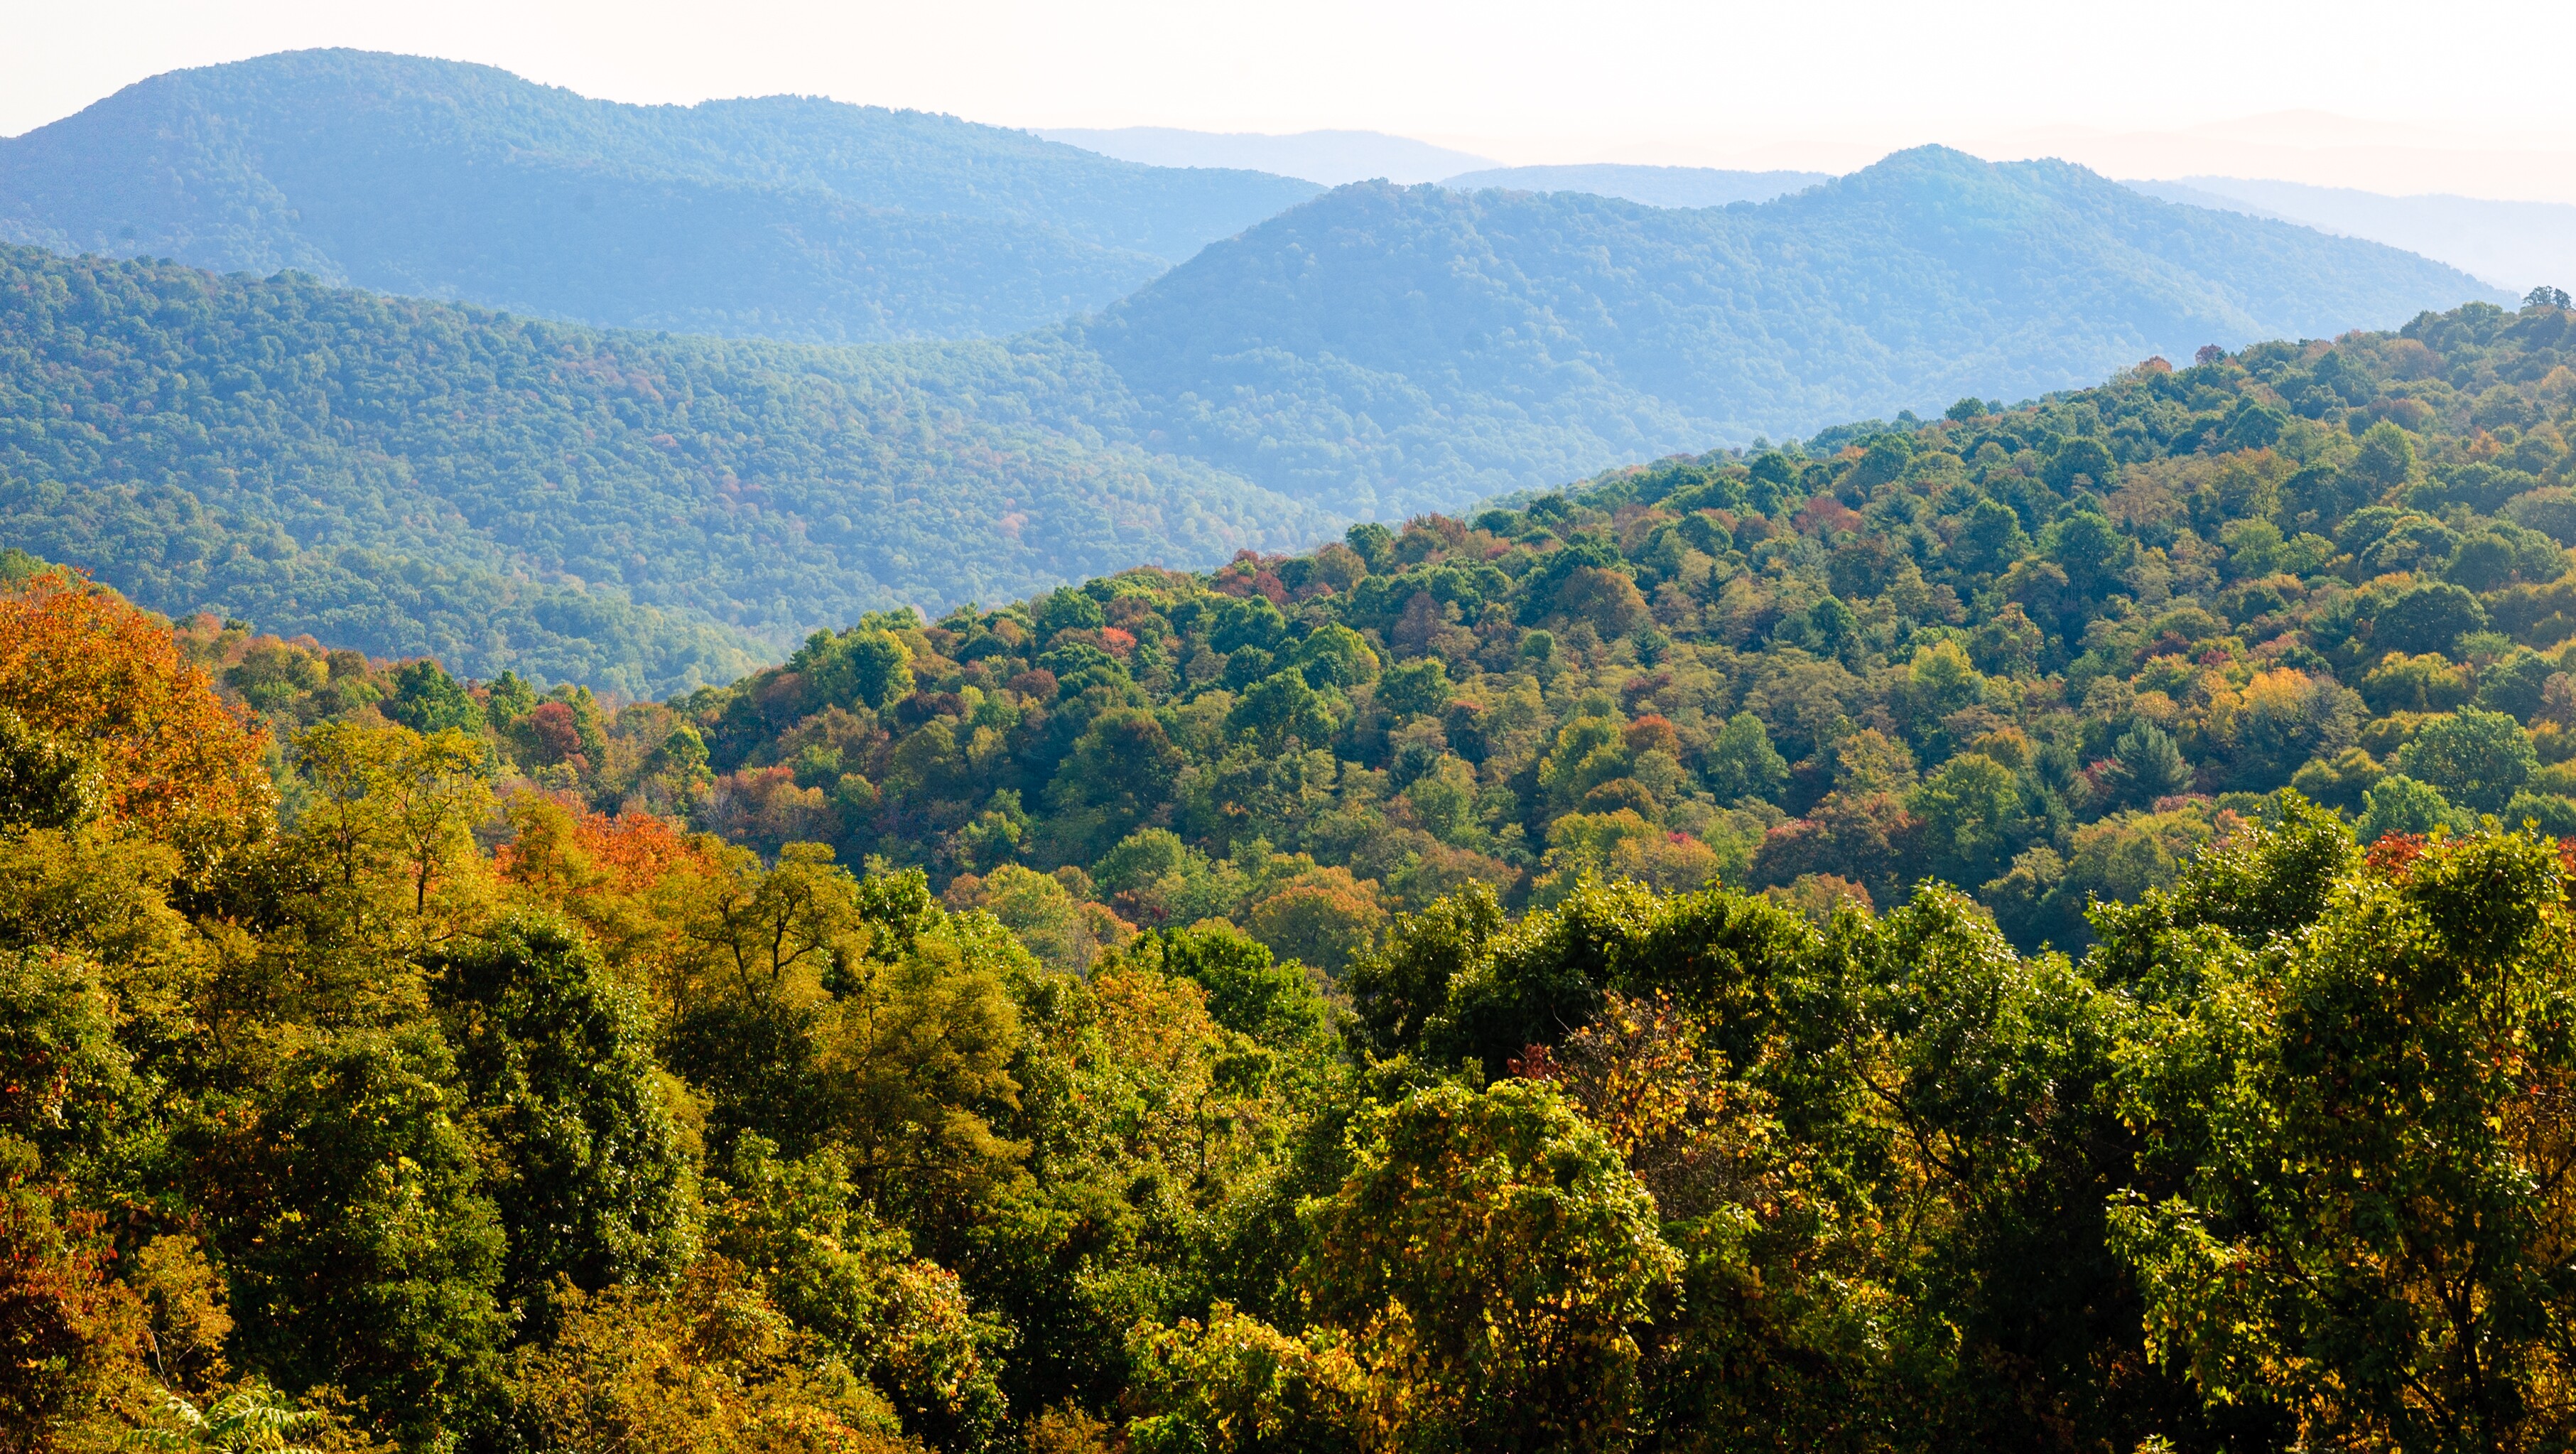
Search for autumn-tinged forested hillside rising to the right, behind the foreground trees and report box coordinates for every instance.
[639,299,2576,964]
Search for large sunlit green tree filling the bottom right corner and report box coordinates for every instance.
[2115,835,2576,1454]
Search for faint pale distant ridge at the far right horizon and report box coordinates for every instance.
[2128,178,2576,294]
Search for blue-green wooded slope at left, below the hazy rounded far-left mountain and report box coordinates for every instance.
[0,247,1334,696]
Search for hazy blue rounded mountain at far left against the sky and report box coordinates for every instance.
[0,52,1316,343]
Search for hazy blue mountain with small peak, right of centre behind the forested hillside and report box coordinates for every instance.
[1074,147,2501,518]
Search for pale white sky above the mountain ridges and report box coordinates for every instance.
[15,0,2576,201]
